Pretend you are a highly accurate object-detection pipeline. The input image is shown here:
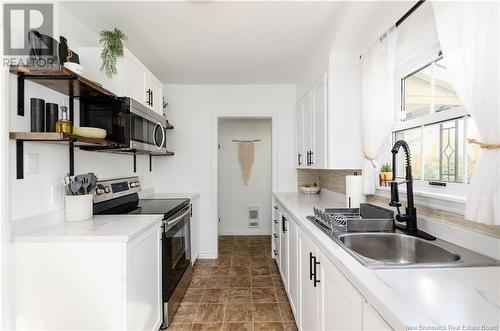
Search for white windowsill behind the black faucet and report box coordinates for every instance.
[375,185,467,215]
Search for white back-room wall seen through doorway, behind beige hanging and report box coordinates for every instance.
[218,119,272,235]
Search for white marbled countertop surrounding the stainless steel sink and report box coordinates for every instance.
[274,192,500,330]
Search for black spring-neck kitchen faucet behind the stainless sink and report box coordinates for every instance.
[389,140,436,240]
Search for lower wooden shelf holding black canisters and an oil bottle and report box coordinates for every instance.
[9,132,115,147]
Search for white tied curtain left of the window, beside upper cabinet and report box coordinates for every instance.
[361,29,397,194]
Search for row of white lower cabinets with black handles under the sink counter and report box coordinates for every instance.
[273,201,392,331]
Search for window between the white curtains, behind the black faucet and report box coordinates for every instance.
[393,57,479,184]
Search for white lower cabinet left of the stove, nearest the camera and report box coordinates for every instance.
[11,223,162,330]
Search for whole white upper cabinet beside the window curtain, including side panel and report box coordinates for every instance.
[295,68,363,169]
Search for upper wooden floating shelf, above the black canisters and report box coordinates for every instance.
[10,65,117,98]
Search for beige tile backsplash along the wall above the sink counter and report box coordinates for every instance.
[297,169,500,238]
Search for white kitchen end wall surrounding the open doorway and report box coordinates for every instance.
[153,85,297,258]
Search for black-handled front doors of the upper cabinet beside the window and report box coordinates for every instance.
[295,74,328,169]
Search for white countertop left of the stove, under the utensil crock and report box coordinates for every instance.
[12,213,163,242]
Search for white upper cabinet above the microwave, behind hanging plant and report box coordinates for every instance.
[78,47,163,115]
